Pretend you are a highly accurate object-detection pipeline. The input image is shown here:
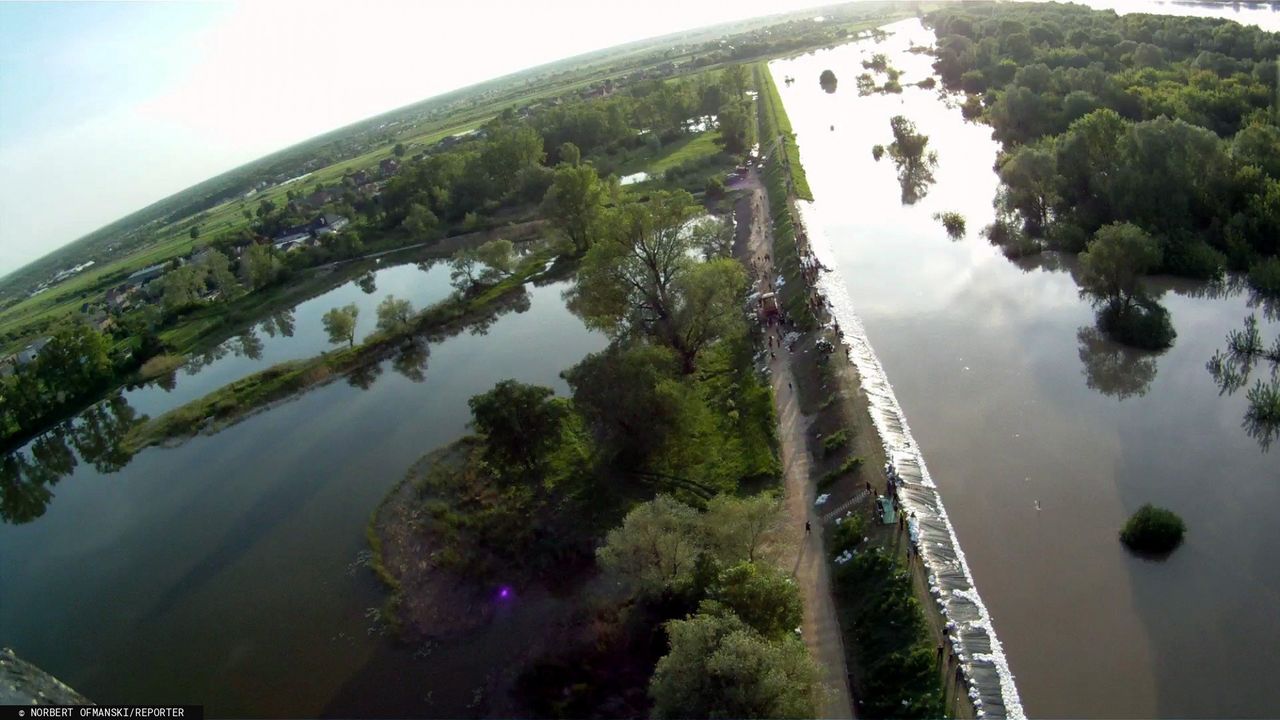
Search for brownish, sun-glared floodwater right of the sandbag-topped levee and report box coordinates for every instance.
[771,12,1280,717]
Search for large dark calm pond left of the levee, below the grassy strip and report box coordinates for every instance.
[0,266,605,717]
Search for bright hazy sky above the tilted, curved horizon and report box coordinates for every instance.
[0,0,839,275]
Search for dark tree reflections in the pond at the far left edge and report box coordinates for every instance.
[0,393,146,525]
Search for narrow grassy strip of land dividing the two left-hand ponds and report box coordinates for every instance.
[124,254,549,452]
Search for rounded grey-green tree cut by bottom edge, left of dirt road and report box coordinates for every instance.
[649,604,818,719]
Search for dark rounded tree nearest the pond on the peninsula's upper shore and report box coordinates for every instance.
[467,380,568,478]
